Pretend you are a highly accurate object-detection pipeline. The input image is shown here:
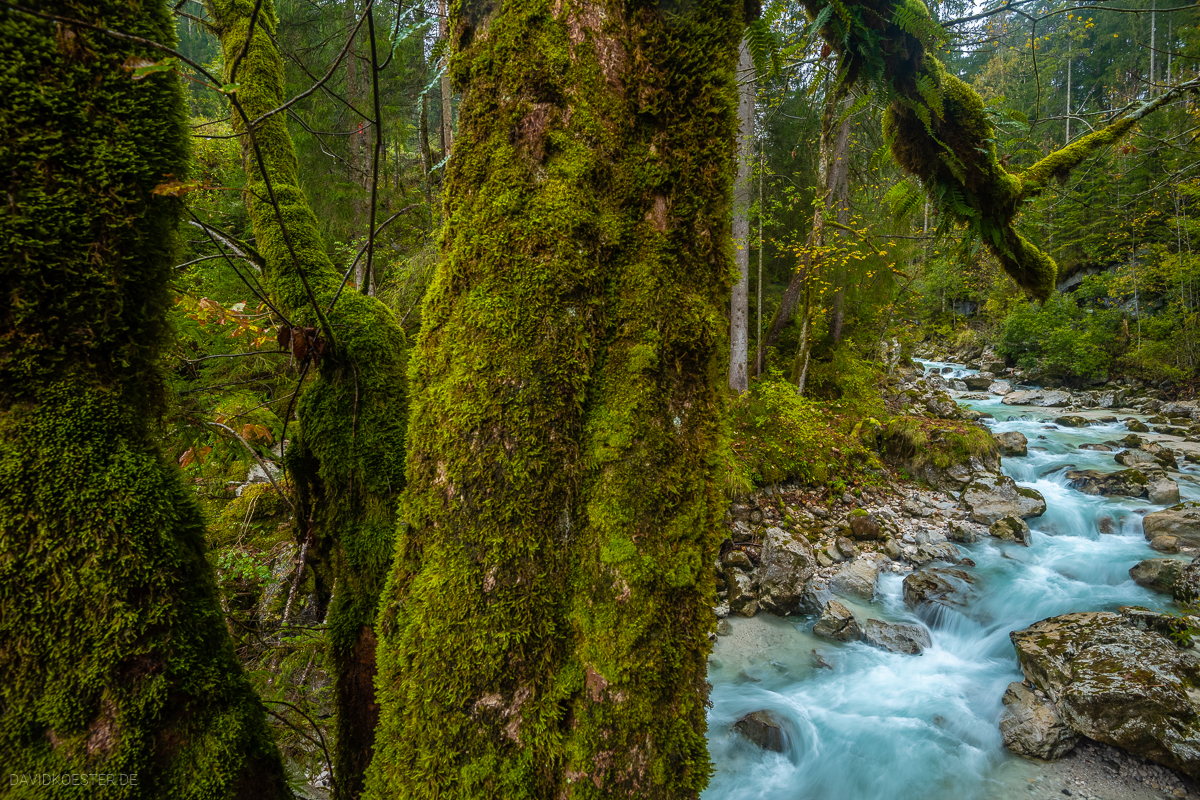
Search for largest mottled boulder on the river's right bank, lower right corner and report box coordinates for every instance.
[1009,609,1200,778]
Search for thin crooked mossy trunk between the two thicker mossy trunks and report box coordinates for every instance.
[209,0,406,798]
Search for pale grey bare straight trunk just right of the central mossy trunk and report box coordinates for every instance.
[730,38,755,392]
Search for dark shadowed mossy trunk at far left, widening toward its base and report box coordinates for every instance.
[0,0,290,800]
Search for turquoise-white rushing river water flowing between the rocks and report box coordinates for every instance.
[703,362,1200,800]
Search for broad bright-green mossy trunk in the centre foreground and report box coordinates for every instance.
[368,0,743,800]
